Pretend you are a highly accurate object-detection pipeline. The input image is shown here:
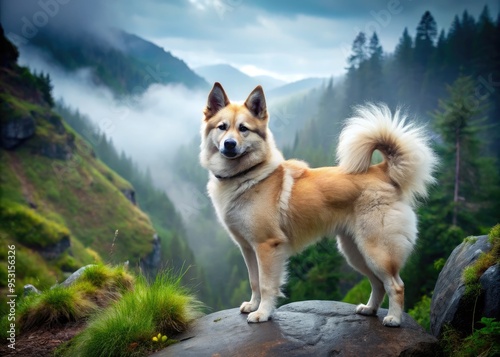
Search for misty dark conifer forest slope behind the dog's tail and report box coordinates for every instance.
[284,7,500,308]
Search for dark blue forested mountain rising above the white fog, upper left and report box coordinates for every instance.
[14,29,209,95]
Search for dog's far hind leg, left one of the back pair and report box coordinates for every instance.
[337,235,385,315]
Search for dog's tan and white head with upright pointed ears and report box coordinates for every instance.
[200,82,274,177]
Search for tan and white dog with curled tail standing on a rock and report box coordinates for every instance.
[200,83,437,327]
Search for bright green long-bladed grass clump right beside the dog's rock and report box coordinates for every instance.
[60,272,201,357]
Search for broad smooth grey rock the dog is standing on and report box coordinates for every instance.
[153,301,439,357]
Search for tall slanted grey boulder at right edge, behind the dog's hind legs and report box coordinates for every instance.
[430,236,500,337]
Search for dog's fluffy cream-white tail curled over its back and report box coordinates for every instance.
[337,104,437,204]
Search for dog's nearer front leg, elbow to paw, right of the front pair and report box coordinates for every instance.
[247,238,290,322]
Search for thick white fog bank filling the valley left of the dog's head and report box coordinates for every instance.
[20,47,207,168]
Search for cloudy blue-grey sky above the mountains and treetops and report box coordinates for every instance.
[1,0,499,81]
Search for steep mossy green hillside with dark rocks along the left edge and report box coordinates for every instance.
[0,28,159,294]
